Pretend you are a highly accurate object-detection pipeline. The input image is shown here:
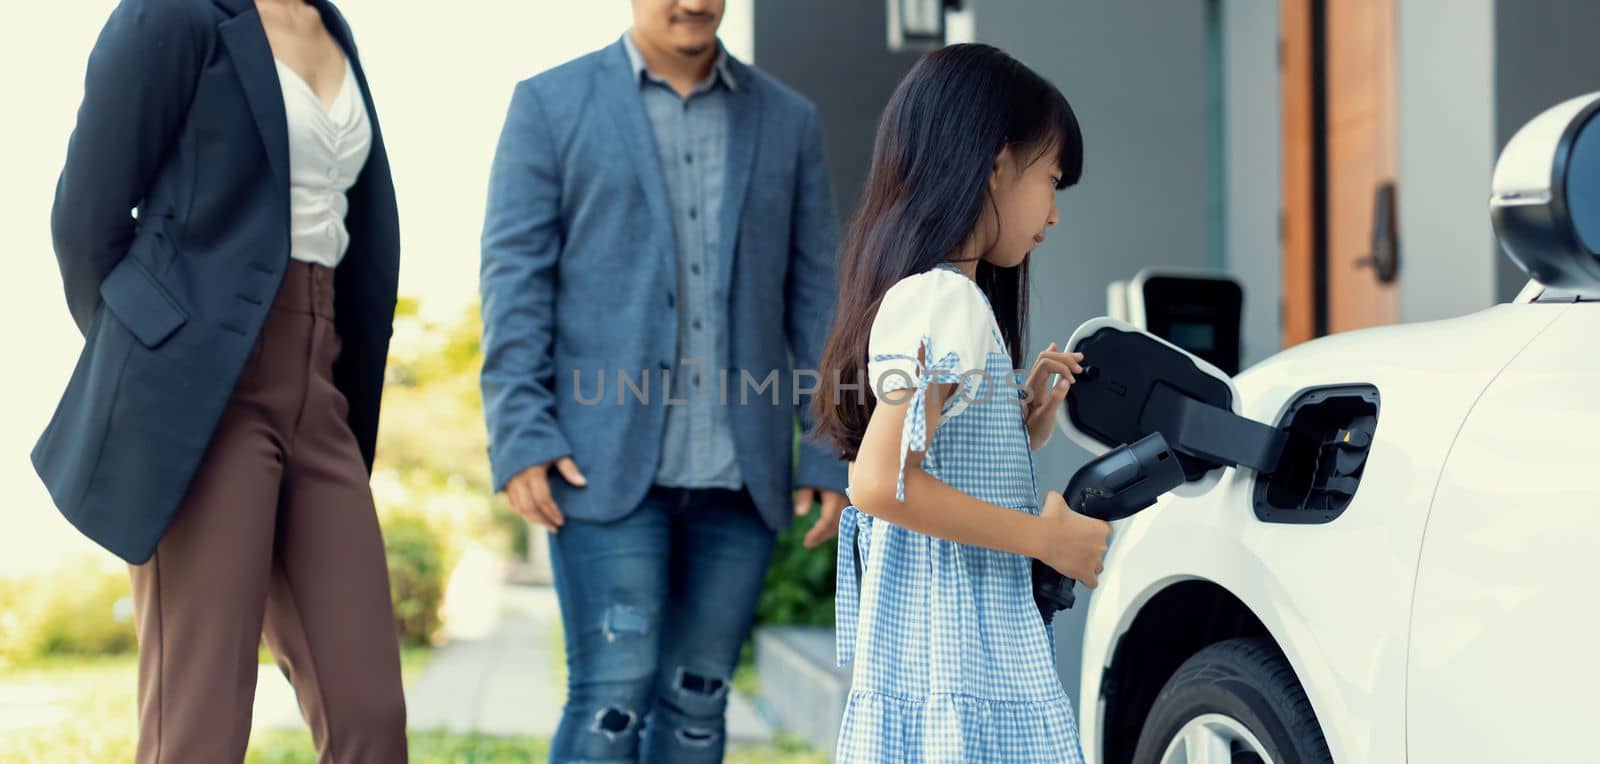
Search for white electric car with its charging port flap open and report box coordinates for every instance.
[1062,93,1600,764]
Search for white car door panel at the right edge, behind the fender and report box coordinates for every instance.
[1406,304,1600,762]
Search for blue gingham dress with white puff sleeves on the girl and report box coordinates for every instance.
[835,265,1083,764]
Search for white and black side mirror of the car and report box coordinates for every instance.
[1490,93,1600,289]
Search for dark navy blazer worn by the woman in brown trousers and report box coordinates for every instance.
[32,0,400,563]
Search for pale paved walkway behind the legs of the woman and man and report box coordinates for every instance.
[254,553,773,745]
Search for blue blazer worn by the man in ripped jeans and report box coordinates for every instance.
[482,40,845,529]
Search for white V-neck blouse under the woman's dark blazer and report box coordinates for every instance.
[274,59,373,269]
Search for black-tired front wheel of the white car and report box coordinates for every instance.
[1133,638,1333,764]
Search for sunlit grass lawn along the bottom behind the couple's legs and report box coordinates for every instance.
[0,649,827,764]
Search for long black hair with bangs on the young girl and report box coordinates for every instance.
[811,45,1083,459]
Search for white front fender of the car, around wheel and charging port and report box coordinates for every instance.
[1080,305,1566,762]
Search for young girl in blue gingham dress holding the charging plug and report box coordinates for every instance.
[814,45,1110,764]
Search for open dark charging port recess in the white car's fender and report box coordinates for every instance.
[1254,385,1378,523]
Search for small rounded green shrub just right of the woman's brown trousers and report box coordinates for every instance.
[384,513,450,646]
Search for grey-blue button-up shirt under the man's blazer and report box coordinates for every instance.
[622,32,744,489]
